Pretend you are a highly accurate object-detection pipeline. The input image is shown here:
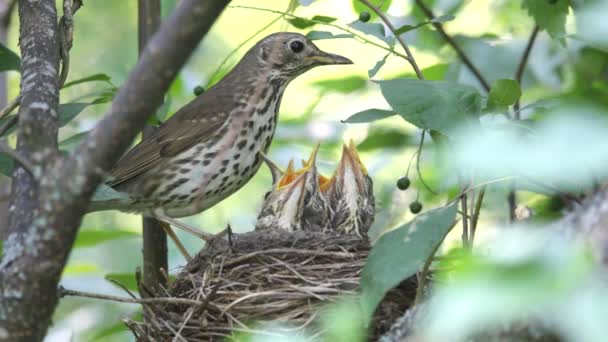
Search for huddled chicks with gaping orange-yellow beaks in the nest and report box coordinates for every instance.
[256,141,375,237]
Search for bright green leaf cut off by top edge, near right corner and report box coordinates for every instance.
[523,0,570,40]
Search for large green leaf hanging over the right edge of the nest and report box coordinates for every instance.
[361,202,458,318]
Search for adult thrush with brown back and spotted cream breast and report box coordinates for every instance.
[90,32,352,240]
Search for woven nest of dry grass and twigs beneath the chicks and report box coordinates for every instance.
[127,230,416,341]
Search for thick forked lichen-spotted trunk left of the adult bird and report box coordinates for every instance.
[0,0,228,341]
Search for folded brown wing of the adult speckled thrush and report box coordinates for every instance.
[107,89,233,186]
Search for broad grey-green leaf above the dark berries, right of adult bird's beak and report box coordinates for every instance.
[375,78,481,134]
